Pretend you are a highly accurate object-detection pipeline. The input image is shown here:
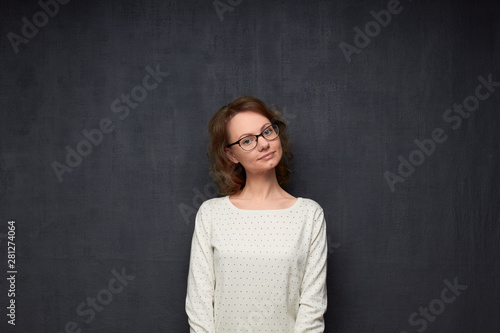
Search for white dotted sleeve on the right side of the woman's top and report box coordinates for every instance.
[294,208,328,333]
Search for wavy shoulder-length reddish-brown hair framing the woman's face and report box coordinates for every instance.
[207,96,293,195]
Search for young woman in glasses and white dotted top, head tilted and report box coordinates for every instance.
[185,96,327,333]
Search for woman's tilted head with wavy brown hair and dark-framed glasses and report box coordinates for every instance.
[208,96,293,195]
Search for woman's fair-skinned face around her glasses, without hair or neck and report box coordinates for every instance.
[225,111,282,173]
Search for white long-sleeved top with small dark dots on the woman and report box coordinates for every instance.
[186,196,327,333]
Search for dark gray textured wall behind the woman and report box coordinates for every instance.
[0,0,500,333]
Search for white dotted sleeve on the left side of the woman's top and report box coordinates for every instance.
[186,201,215,333]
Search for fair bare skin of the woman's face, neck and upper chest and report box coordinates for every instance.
[224,111,297,210]
